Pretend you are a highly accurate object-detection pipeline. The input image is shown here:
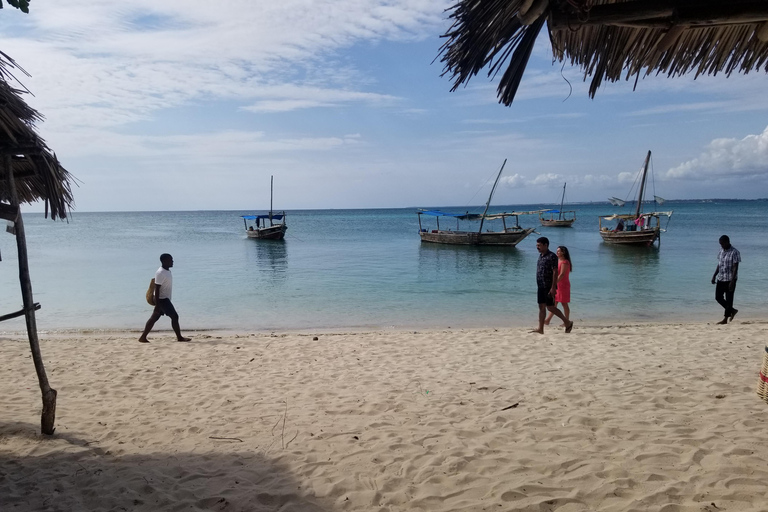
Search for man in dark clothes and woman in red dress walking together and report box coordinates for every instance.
[531,237,573,334]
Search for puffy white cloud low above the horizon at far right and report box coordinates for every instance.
[665,127,768,181]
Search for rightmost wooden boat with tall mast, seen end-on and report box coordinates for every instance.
[599,151,672,247]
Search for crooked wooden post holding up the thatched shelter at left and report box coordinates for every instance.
[2,155,57,435]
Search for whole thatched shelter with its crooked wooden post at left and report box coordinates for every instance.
[0,52,74,434]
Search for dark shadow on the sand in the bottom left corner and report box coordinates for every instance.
[0,422,329,512]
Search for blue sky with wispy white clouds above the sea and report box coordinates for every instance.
[0,0,768,212]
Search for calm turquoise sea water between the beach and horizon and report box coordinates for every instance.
[0,200,768,332]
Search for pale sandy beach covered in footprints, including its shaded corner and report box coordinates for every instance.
[0,318,768,512]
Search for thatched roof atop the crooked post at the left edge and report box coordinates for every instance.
[0,52,74,219]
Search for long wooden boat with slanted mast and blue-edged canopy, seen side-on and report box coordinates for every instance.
[416,159,539,247]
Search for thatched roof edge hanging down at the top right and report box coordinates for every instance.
[441,0,768,105]
